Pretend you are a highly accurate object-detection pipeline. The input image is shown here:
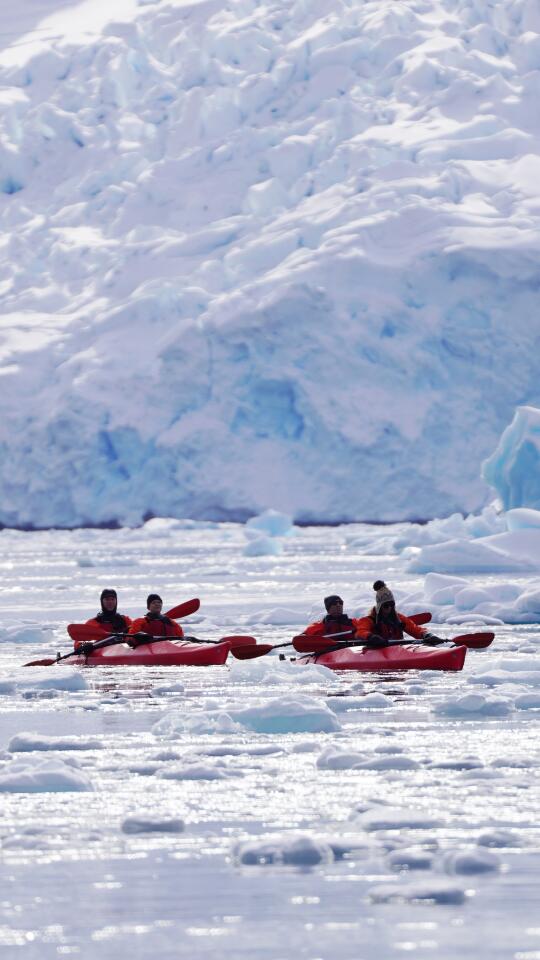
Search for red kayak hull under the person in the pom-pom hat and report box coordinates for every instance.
[297,644,467,672]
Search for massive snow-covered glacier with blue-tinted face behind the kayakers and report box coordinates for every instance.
[0,0,540,524]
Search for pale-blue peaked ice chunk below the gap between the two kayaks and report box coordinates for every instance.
[230,696,341,733]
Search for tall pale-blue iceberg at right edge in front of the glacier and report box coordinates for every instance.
[482,406,540,510]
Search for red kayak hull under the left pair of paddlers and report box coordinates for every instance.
[65,640,231,667]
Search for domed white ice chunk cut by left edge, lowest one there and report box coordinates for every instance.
[0,757,94,793]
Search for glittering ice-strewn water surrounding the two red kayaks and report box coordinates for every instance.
[0,525,540,960]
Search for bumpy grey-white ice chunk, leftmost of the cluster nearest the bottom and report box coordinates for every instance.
[233,835,334,867]
